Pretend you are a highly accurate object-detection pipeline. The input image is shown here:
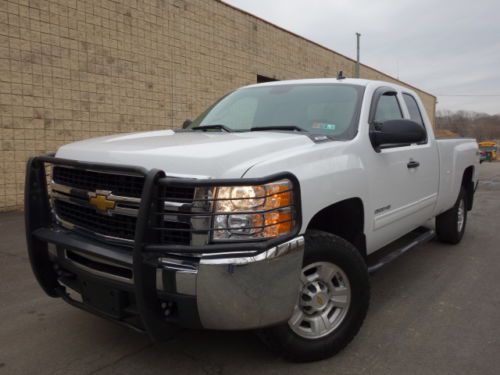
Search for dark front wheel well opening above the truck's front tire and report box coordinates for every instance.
[307,197,366,258]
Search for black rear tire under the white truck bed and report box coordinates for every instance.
[436,187,467,245]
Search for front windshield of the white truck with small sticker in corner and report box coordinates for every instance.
[189,84,364,138]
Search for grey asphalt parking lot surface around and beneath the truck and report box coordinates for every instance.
[0,163,500,375]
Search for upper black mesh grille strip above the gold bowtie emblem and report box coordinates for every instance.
[52,167,144,198]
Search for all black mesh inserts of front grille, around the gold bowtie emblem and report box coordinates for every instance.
[52,166,195,246]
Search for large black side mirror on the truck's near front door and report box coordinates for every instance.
[370,119,427,152]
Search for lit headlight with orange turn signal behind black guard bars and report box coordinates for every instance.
[213,180,295,241]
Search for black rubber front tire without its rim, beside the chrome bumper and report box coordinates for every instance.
[260,231,370,362]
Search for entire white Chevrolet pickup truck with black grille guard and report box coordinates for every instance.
[25,79,479,361]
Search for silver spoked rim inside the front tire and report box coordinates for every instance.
[288,262,351,339]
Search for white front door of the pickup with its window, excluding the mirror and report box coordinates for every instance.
[367,87,439,253]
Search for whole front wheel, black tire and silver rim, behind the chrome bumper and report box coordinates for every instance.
[262,231,370,362]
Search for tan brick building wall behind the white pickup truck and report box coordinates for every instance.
[0,0,435,210]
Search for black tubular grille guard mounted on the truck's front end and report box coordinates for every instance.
[24,154,301,341]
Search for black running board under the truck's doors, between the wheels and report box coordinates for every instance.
[368,227,436,273]
